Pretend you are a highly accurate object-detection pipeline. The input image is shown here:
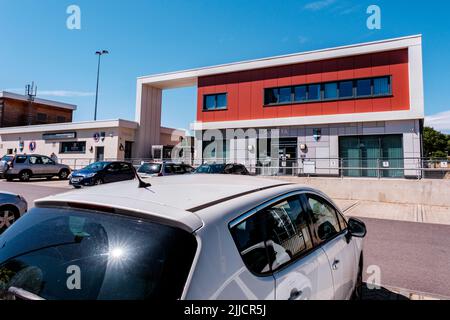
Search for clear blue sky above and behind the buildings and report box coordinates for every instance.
[0,0,450,130]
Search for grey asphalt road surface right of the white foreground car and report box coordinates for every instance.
[362,218,450,299]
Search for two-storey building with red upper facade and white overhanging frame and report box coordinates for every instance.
[135,35,424,177]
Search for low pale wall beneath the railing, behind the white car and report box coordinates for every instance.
[270,177,450,207]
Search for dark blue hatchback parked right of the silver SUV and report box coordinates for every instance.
[69,161,135,188]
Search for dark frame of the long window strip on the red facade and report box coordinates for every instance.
[263,75,393,107]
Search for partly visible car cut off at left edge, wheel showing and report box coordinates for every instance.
[0,192,28,234]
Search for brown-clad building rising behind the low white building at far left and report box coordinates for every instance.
[0,91,77,128]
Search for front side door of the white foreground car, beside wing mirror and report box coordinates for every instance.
[304,193,358,300]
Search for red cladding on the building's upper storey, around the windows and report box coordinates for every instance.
[197,49,410,122]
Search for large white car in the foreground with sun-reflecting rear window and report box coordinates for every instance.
[0,174,366,300]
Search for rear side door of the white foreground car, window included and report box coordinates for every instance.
[265,195,334,300]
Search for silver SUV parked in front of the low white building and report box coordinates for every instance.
[4,154,70,182]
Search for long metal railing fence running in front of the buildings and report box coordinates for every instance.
[54,158,450,179]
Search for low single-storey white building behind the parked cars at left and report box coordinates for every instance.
[0,119,186,168]
